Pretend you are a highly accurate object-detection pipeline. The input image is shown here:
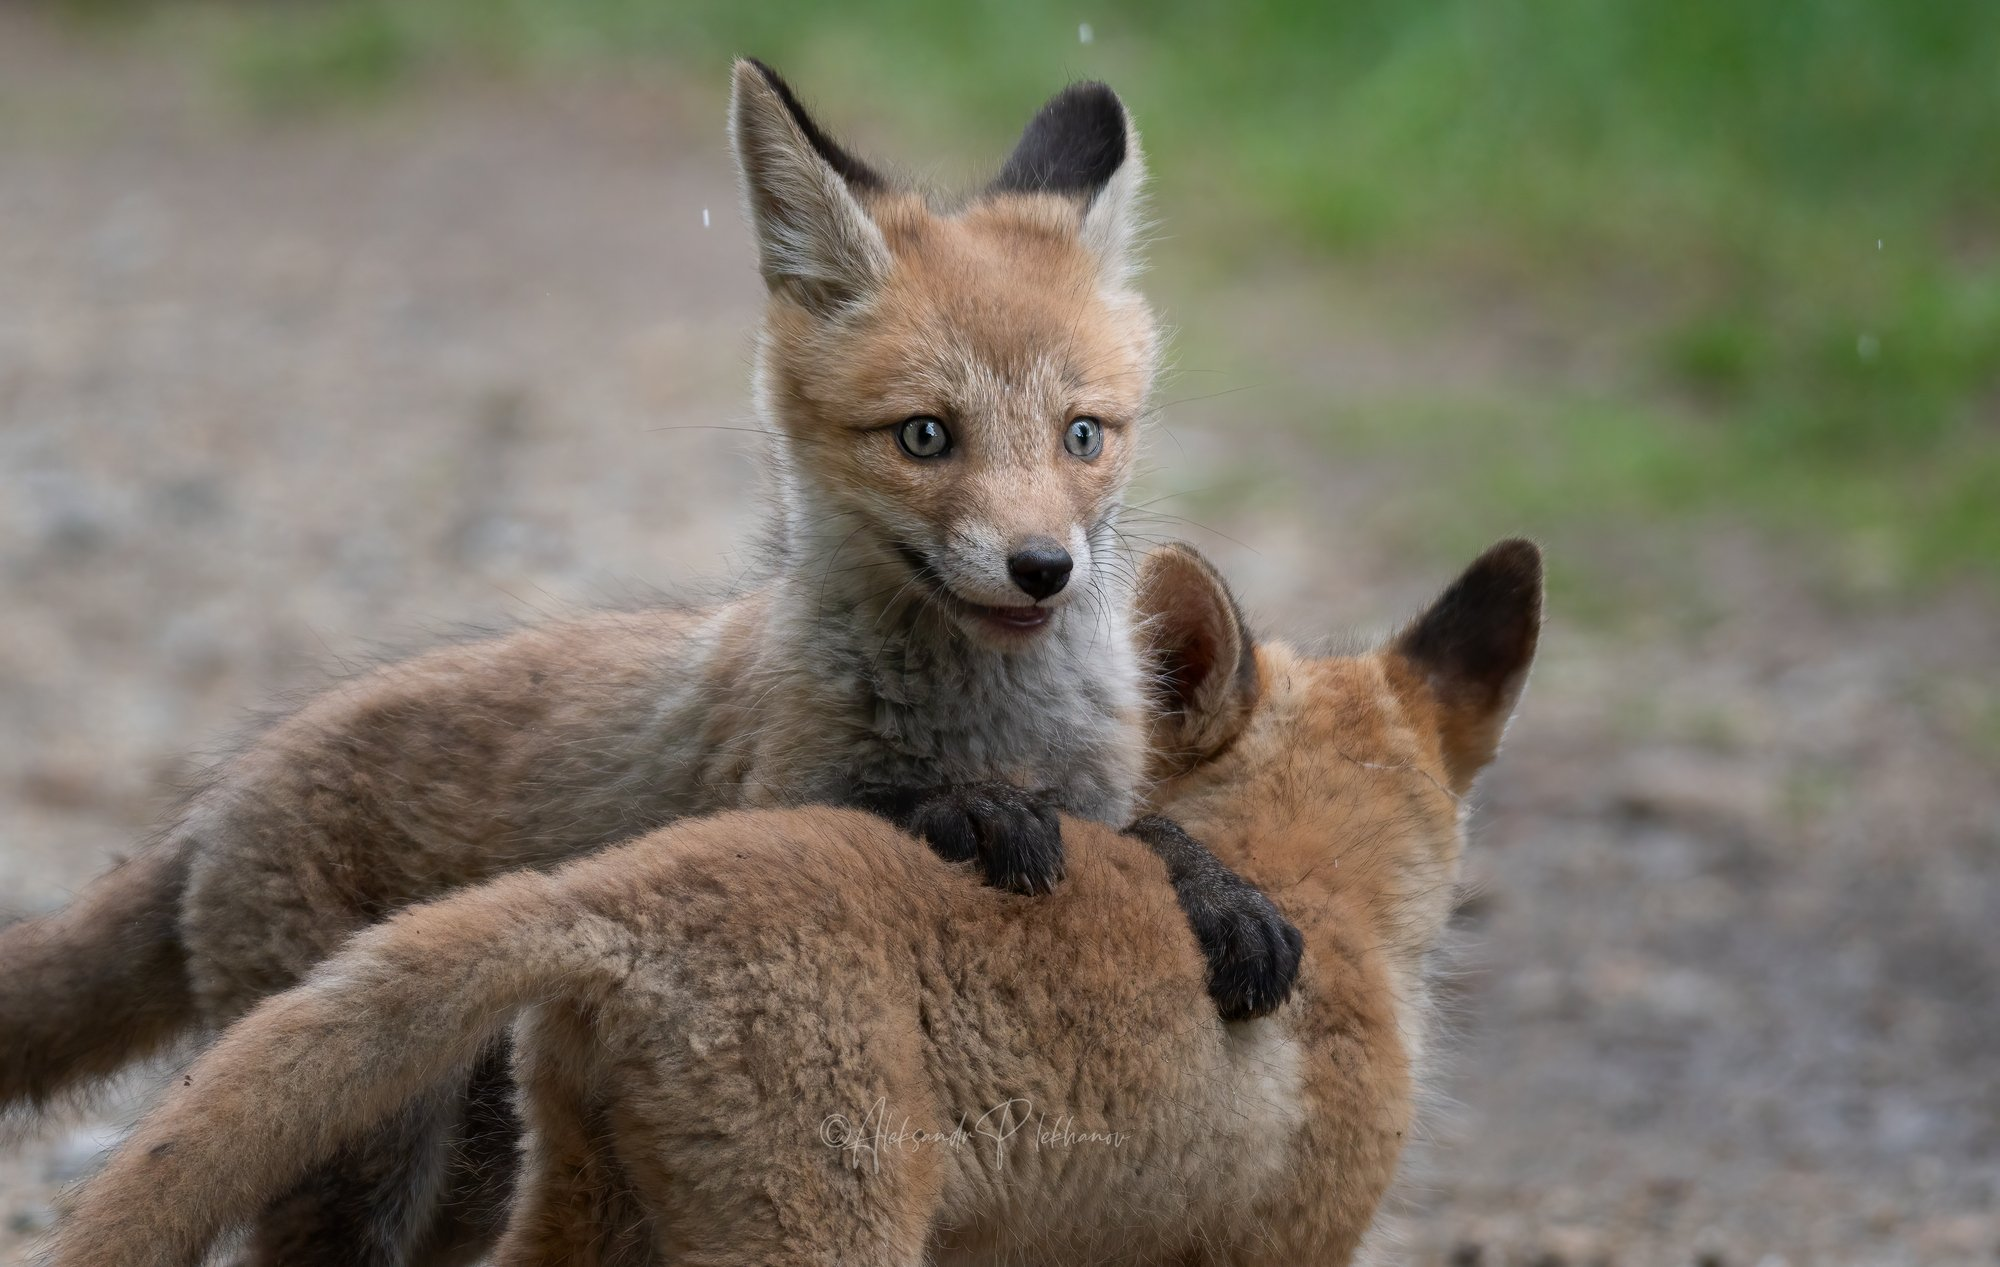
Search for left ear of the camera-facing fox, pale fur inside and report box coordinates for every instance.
[730,58,890,312]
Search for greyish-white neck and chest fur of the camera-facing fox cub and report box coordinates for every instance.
[726,463,1146,823]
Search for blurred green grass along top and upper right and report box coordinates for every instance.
[98,0,2000,588]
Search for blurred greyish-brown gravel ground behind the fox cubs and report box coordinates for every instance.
[0,12,2000,1267]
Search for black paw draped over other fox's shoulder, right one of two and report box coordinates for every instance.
[1128,815,1306,1021]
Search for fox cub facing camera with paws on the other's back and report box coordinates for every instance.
[0,62,1296,1265]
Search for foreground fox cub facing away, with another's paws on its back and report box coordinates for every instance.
[54,542,1542,1267]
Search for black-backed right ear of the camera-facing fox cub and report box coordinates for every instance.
[992,82,1146,280]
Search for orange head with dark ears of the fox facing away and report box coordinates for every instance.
[1136,540,1542,961]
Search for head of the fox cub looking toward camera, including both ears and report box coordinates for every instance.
[730,62,1158,649]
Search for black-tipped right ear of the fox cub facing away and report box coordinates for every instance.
[1390,538,1542,793]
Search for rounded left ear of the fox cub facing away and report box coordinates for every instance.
[1134,542,1260,777]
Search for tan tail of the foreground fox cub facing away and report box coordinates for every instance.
[50,873,604,1267]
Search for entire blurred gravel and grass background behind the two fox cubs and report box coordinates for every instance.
[0,0,2000,1267]
